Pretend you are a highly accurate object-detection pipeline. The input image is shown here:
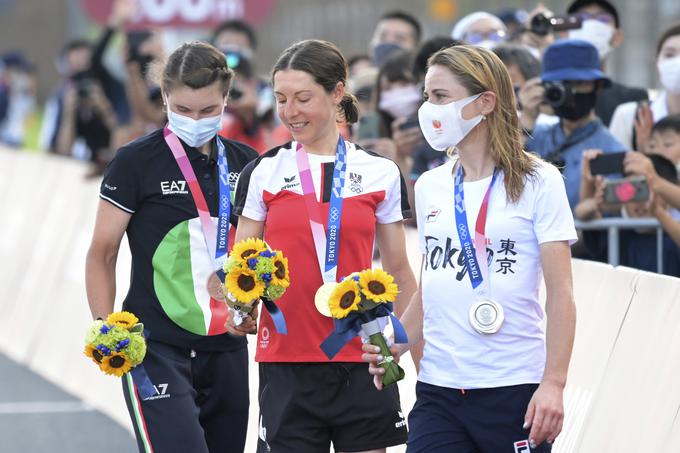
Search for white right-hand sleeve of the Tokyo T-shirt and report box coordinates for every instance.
[533,163,577,245]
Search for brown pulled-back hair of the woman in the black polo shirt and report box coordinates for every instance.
[155,41,234,97]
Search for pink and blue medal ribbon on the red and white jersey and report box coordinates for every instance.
[294,137,347,283]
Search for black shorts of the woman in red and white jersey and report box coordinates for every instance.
[257,363,407,453]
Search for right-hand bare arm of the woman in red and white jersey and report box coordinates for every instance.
[376,221,416,317]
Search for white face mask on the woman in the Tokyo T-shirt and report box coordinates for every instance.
[418,93,484,151]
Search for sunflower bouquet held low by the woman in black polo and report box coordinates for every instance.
[85,311,146,377]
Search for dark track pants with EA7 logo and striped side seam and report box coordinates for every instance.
[123,341,249,453]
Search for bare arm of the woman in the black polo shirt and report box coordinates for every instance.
[85,200,132,318]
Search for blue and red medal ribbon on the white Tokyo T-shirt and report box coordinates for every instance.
[453,161,498,295]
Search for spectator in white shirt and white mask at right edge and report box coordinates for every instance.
[609,23,680,151]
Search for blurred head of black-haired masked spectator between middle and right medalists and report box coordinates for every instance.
[369,10,422,67]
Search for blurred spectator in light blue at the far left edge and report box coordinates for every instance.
[0,51,36,147]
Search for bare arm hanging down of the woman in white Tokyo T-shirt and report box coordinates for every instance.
[524,241,576,445]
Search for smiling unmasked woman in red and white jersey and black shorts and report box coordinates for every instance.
[231,40,416,452]
